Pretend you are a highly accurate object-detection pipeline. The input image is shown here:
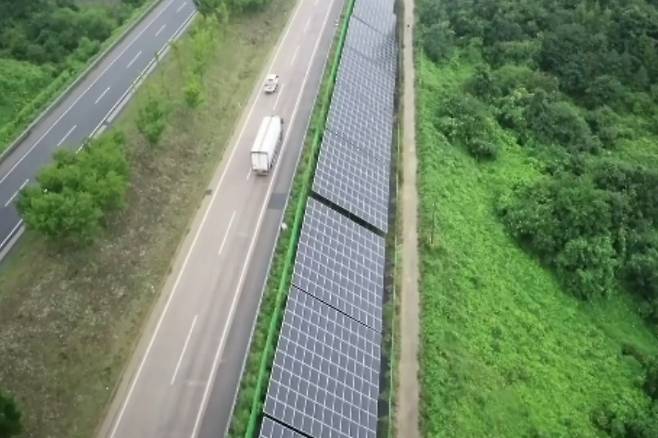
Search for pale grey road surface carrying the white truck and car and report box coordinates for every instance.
[100,0,343,438]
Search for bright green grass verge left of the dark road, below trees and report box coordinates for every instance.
[0,0,160,153]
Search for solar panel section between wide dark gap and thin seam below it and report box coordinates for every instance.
[292,198,388,330]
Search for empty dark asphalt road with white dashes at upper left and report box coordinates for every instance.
[0,0,196,252]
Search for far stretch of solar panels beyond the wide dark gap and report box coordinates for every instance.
[313,0,397,232]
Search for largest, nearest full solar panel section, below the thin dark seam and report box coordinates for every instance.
[264,287,381,438]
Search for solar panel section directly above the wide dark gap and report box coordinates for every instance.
[313,132,390,232]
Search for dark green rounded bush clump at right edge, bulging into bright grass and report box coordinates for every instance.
[499,160,658,304]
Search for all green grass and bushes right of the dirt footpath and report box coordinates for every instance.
[418,0,658,437]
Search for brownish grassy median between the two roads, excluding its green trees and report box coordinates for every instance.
[0,0,294,438]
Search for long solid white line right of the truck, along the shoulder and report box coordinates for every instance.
[190,0,335,432]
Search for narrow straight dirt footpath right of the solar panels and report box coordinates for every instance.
[396,0,420,438]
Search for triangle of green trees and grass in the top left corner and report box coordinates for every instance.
[0,0,146,149]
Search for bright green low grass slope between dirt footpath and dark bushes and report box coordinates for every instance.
[417,57,658,437]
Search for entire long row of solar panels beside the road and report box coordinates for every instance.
[260,0,397,438]
